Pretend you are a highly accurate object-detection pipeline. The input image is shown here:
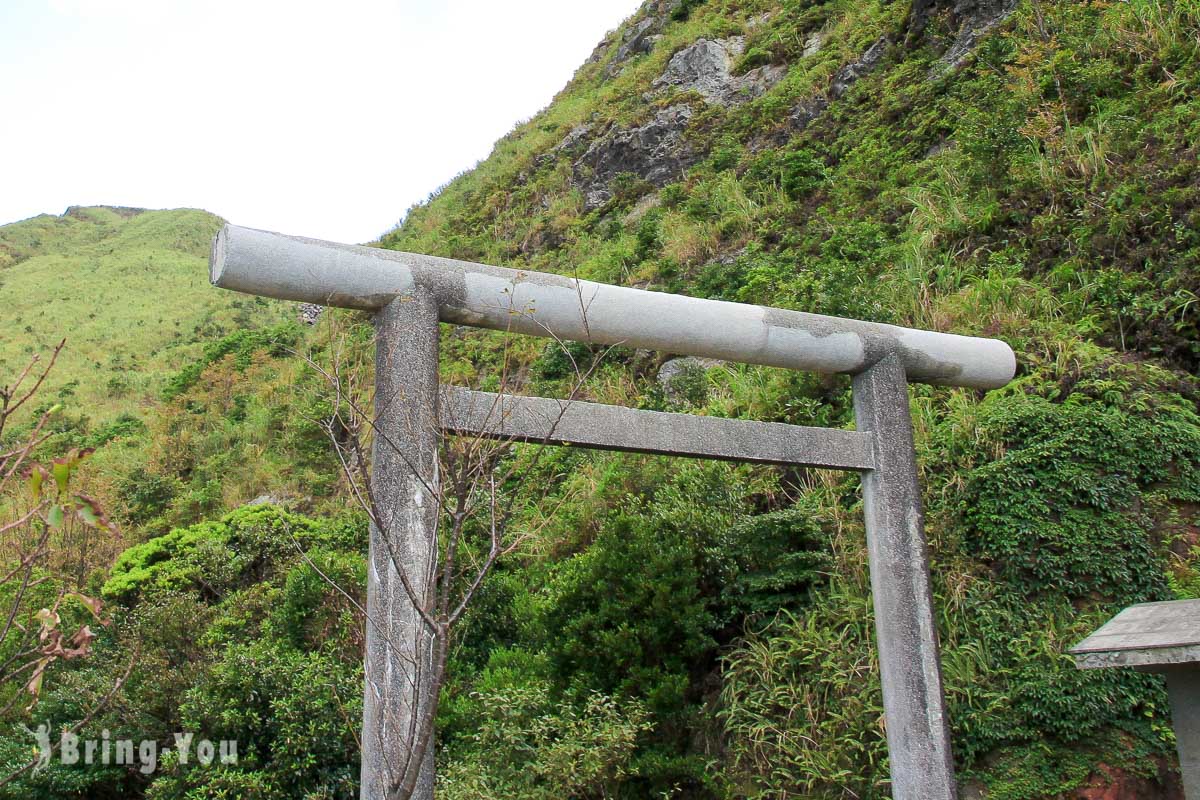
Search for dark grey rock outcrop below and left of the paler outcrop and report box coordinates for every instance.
[574,104,698,209]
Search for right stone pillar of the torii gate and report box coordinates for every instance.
[854,355,956,800]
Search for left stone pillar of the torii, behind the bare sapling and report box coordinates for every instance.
[360,290,440,800]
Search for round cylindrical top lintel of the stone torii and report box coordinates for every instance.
[211,225,1016,389]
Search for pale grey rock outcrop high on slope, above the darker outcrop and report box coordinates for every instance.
[653,36,787,106]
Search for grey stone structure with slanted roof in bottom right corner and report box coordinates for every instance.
[1070,600,1200,800]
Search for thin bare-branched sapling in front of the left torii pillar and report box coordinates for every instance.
[306,314,606,800]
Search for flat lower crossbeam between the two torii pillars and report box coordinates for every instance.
[440,386,875,470]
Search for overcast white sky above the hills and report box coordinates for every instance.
[0,0,640,242]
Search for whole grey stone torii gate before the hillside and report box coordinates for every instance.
[211,225,1016,800]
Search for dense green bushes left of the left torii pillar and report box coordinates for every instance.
[0,505,366,800]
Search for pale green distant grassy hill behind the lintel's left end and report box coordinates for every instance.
[0,206,290,431]
